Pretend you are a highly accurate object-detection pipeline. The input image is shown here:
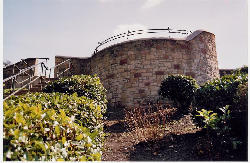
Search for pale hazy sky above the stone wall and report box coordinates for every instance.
[3,0,248,68]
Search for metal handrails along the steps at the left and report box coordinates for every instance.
[3,59,71,100]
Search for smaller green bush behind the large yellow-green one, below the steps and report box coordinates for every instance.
[43,75,107,105]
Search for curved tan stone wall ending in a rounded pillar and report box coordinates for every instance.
[56,31,219,106]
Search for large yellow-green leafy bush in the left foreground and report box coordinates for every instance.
[3,93,105,161]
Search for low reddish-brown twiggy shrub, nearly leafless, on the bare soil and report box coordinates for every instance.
[124,103,175,142]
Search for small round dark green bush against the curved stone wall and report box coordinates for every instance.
[159,75,198,113]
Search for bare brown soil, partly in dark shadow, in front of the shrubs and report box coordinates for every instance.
[102,111,247,161]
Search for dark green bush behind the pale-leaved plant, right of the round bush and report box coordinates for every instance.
[195,74,248,112]
